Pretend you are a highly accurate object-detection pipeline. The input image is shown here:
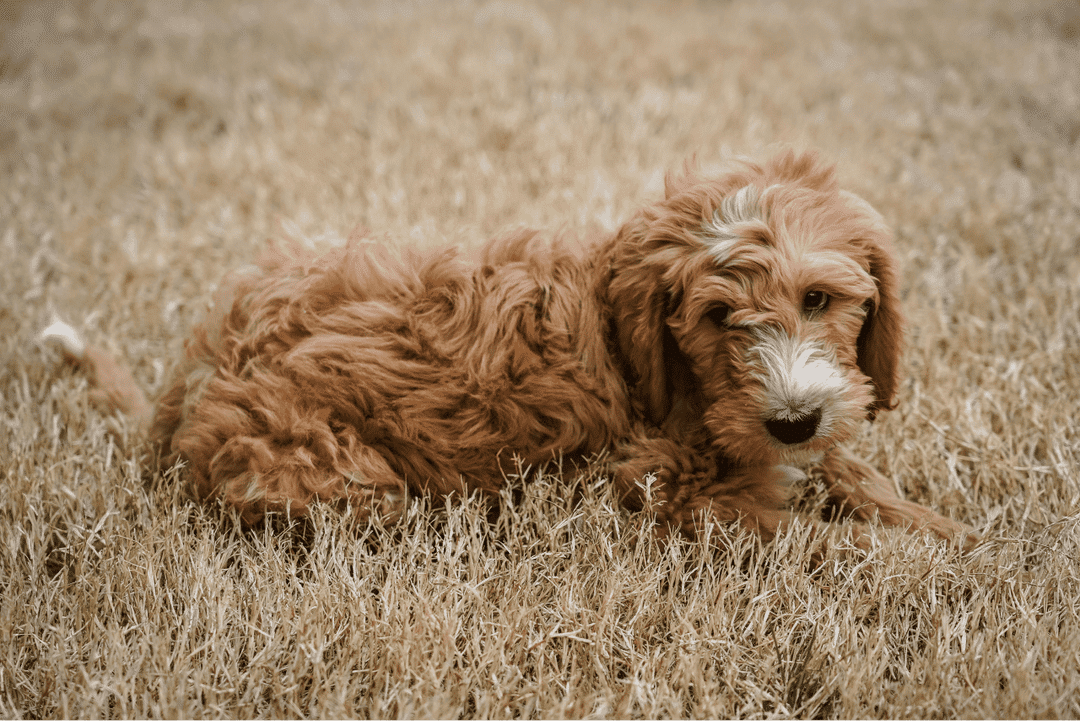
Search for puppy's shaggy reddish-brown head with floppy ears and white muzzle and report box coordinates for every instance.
[607,151,903,462]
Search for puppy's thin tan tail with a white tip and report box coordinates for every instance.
[40,321,153,436]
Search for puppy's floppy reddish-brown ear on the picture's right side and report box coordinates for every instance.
[842,192,904,421]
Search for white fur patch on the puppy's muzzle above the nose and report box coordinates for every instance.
[750,327,846,435]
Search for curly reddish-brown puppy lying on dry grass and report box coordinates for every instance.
[45,150,977,547]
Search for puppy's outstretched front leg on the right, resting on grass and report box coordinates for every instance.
[813,446,980,550]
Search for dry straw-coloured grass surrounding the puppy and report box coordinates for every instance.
[0,0,1080,719]
